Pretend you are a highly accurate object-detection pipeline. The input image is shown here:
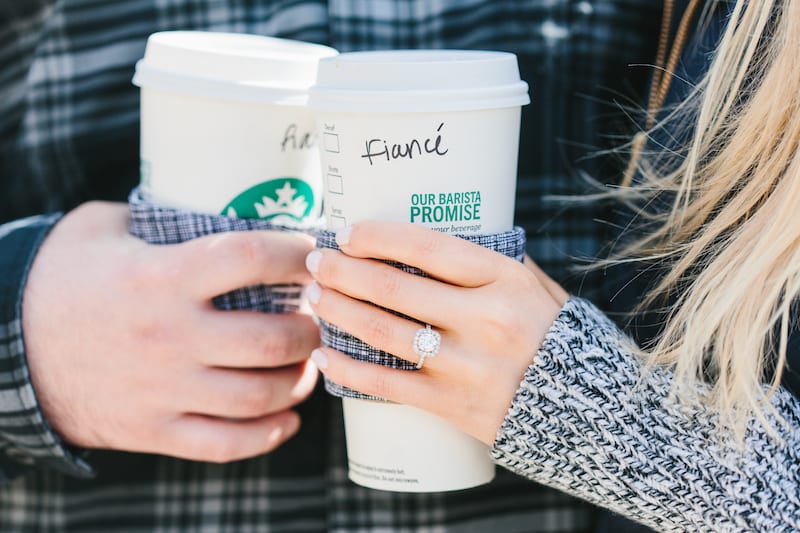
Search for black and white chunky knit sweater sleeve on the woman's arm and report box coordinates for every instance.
[492,298,800,532]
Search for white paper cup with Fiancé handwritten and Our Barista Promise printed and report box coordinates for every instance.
[309,50,530,492]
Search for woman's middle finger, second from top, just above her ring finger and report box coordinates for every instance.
[307,250,468,329]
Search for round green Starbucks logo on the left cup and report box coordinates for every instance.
[222,178,314,222]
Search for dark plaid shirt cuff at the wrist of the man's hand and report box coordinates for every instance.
[0,215,92,483]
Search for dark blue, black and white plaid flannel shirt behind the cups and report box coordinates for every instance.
[0,0,661,532]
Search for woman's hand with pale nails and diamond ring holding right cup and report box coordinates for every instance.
[306,222,567,444]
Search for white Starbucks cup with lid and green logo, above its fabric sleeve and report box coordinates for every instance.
[133,31,337,222]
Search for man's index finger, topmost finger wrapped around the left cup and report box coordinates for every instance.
[148,231,314,299]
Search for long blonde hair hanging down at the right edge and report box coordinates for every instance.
[620,0,800,435]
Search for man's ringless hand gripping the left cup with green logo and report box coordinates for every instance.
[23,202,319,462]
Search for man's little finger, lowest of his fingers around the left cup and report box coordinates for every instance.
[162,411,300,463]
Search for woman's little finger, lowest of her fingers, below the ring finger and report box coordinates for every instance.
[311,348,432,407]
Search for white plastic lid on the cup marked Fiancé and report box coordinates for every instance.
[309,50,530,112]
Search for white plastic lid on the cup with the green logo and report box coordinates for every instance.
[133,31,337,105]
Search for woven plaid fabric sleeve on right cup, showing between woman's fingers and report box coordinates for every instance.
[317,227,525,400]
